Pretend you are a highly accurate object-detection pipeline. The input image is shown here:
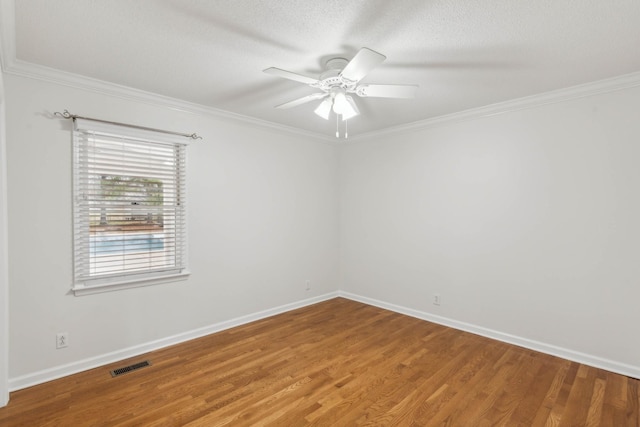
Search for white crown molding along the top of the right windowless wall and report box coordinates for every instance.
[347,72,640,144]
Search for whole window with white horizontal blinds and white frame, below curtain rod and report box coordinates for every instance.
[73,119,188,295]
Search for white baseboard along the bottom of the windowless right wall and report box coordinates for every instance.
[338,291,640,379]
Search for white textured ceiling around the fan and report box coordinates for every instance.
[2,0,640,135]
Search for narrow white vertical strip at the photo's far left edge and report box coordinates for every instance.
[0,72,9,407]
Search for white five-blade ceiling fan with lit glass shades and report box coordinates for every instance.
[264,47,418,133]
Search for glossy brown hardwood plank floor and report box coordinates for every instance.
[0,298,640,427]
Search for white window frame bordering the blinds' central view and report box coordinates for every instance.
[71,118,190,296]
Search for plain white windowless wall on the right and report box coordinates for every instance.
[339,87,640,377]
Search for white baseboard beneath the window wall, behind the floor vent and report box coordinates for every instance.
[9,292,339,391]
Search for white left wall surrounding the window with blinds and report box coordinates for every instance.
[5,75,338,388]
